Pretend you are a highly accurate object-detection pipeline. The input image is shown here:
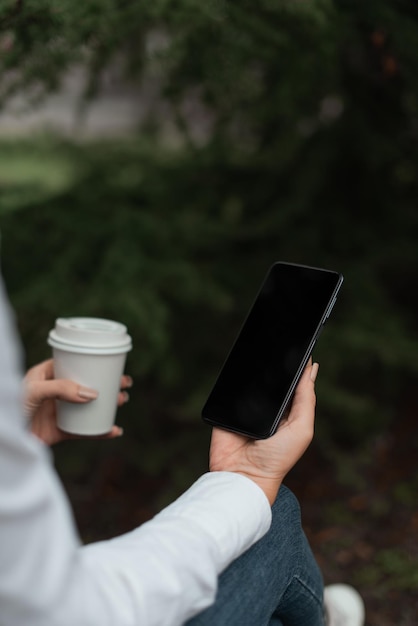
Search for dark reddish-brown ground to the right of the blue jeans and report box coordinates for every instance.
[289,404,418,626]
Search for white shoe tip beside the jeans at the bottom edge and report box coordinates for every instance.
[324,584,366,626]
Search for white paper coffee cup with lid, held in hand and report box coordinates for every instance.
[48,317,132,435]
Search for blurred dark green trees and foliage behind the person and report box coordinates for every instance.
[0,0,418,625]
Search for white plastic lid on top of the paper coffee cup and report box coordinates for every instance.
[48,317,132,354]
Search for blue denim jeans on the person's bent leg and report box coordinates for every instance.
[187,486,324,626]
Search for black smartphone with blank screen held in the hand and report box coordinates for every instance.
[202,262,343,439]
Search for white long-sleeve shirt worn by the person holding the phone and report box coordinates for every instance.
[0,276,271,626]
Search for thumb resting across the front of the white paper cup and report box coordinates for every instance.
[26,379,99,406]
